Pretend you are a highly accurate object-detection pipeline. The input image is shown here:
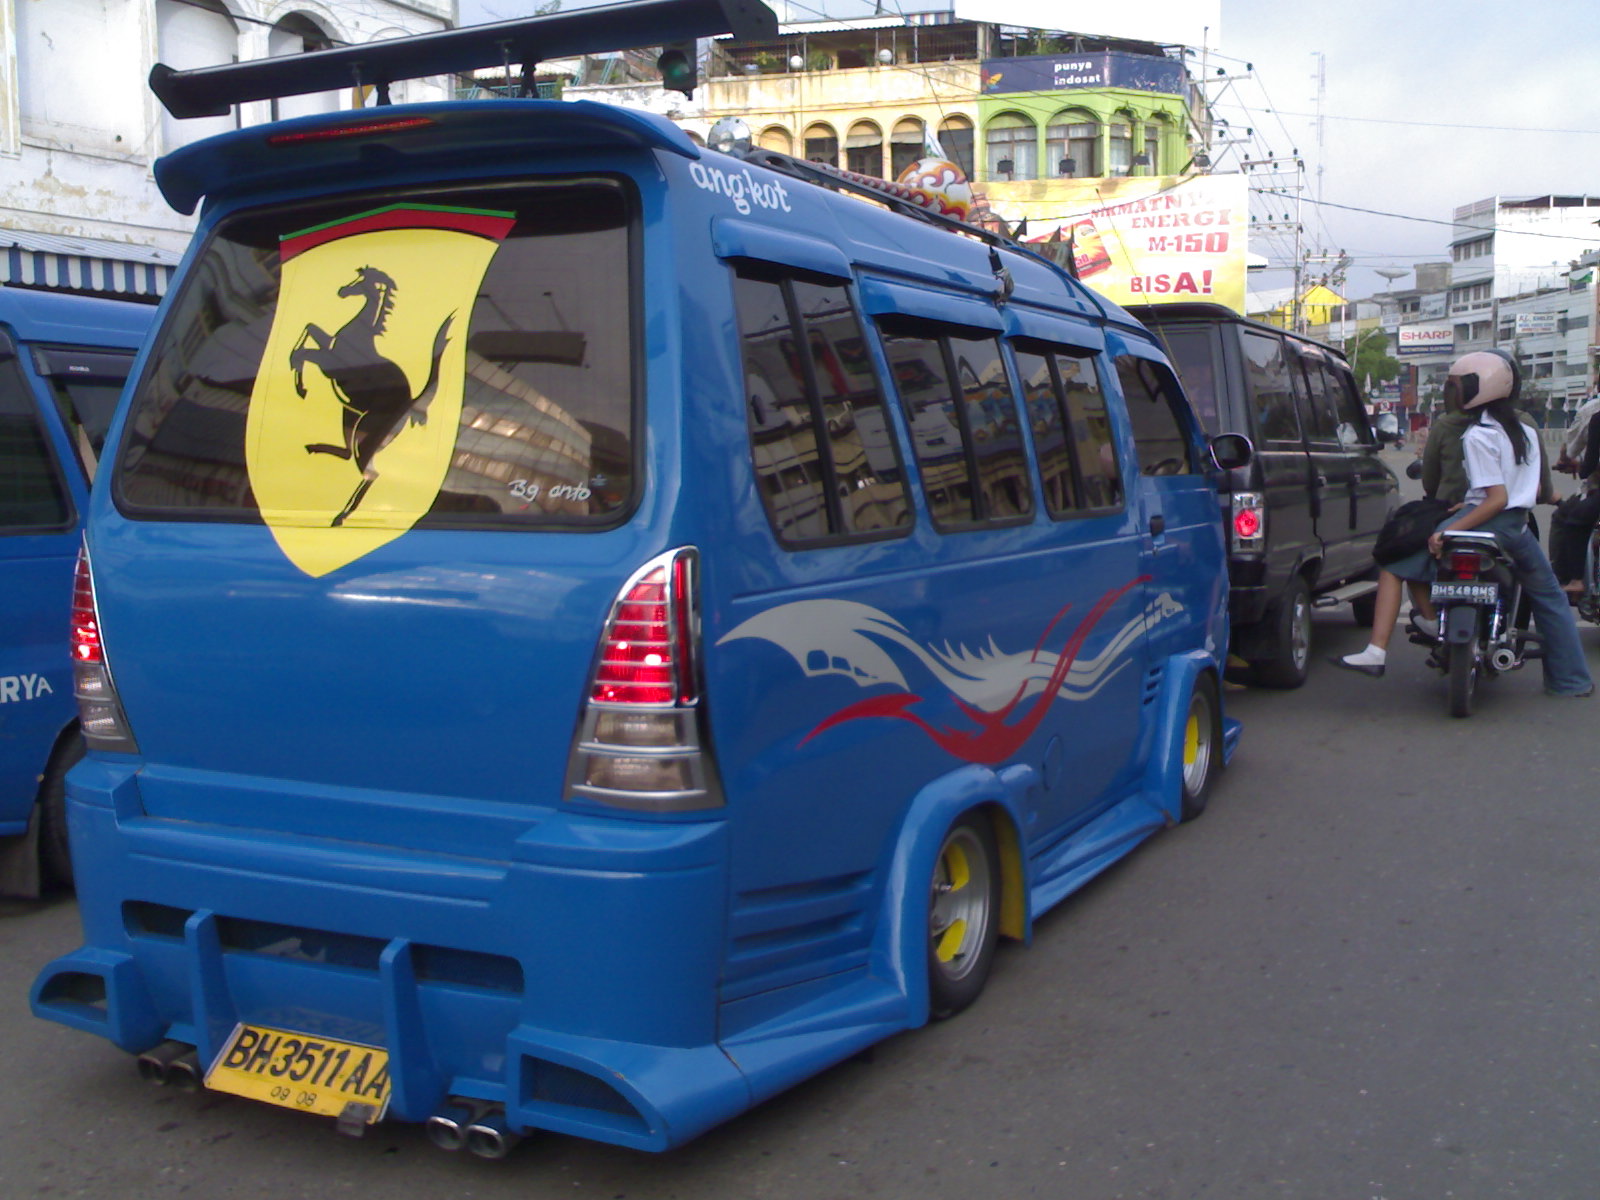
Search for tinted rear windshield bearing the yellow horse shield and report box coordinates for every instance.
[115,178,638,528]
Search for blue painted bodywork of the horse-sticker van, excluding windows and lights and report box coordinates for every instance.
[32,101,1237,1150]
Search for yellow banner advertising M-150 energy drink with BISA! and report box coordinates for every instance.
[1026,174,1250,312]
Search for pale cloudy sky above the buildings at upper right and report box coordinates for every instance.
[461,0,1600,299]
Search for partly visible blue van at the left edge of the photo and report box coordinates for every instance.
[0,288,155,896]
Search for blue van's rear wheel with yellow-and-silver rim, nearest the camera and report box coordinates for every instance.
[928,813,1000,1018]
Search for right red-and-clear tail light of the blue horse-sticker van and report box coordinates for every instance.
[566,547,722,813]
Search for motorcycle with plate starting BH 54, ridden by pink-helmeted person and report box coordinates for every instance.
[1410,530,1542,717]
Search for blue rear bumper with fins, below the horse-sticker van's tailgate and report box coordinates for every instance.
[32,760,754,1150]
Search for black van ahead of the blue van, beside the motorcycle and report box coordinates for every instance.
[1131,304,1400,688]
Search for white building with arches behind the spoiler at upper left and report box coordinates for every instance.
[0,0,456,296]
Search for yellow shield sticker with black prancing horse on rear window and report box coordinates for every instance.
[245,205,515,576]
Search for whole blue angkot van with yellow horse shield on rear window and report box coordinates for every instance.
[32,5,1250,1157]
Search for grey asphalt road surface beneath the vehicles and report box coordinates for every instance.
[0,454,1600,1200]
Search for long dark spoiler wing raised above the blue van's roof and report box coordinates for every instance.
[150,0,778,117]
